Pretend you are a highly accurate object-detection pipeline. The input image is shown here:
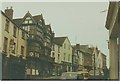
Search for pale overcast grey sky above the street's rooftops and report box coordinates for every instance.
[2,2,109,67]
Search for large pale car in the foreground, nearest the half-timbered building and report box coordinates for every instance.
[60,71,89,80]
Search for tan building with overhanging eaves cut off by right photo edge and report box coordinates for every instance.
[105,1,120,79]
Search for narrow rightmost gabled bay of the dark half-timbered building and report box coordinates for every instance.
[44,24,54,75]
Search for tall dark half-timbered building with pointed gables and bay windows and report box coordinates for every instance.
[14,11,54,79]
